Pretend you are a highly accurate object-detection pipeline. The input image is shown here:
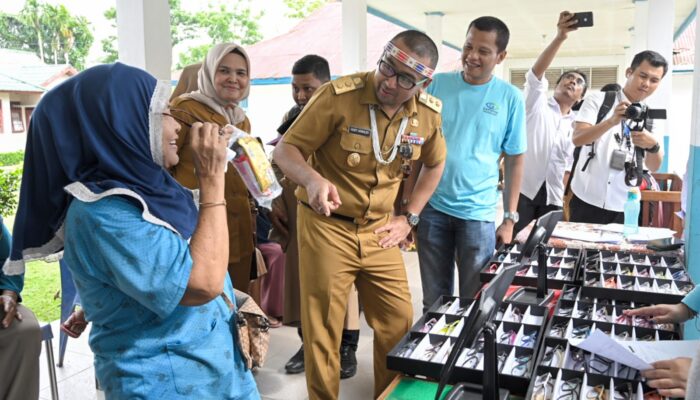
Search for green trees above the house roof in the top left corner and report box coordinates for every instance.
[0,0,93,69]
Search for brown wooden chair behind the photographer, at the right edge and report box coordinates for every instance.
[641,173,683,237]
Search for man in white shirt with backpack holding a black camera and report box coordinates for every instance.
[569,50,668,224]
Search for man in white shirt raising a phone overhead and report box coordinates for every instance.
[515,11,587,232]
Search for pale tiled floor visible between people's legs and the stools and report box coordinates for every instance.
[40,252,422,400]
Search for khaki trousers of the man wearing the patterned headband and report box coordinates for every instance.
[297,205,413,400]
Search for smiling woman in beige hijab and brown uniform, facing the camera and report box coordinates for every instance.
[170,43,255,292]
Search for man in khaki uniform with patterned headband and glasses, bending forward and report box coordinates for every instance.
[274,31,446,399]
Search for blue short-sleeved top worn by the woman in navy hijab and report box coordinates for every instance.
[64,196,260,399]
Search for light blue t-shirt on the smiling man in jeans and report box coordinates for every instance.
[428,72,527,222]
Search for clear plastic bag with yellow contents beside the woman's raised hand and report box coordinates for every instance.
[224,125,282,210]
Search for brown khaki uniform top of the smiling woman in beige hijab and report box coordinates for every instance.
[170,97,254,264]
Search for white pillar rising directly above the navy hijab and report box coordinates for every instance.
[117,0,172,80]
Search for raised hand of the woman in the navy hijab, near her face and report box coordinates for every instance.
[190,122,232,179]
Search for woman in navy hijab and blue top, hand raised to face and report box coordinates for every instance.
[4,63,260,399]
